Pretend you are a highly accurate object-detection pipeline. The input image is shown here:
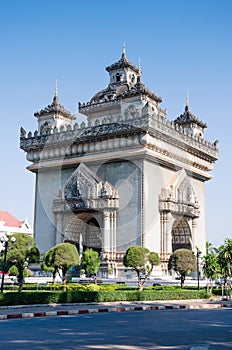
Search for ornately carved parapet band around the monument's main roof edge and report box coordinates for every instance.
[20,105,218,171]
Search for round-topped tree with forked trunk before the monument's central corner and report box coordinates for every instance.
[123,246,160,291]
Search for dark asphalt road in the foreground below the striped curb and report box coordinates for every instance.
[0,308,232,350]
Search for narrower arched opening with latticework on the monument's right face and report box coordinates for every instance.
[172,218,192,252]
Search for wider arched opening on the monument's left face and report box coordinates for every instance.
[64,213,102,254]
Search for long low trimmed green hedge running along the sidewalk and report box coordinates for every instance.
[0,289,209,305]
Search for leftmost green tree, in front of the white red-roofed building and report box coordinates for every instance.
[7,233,35,292]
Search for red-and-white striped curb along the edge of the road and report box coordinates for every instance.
[0,304,228,320]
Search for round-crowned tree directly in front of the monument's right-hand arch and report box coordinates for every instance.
[168,249,197,288]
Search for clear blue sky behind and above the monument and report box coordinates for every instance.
[0,0,232,246]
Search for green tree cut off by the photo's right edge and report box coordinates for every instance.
[217,238,232,285]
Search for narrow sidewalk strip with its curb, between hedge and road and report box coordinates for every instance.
[0,299,232,320]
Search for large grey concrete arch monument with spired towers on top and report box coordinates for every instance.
[20,48,218,277]
